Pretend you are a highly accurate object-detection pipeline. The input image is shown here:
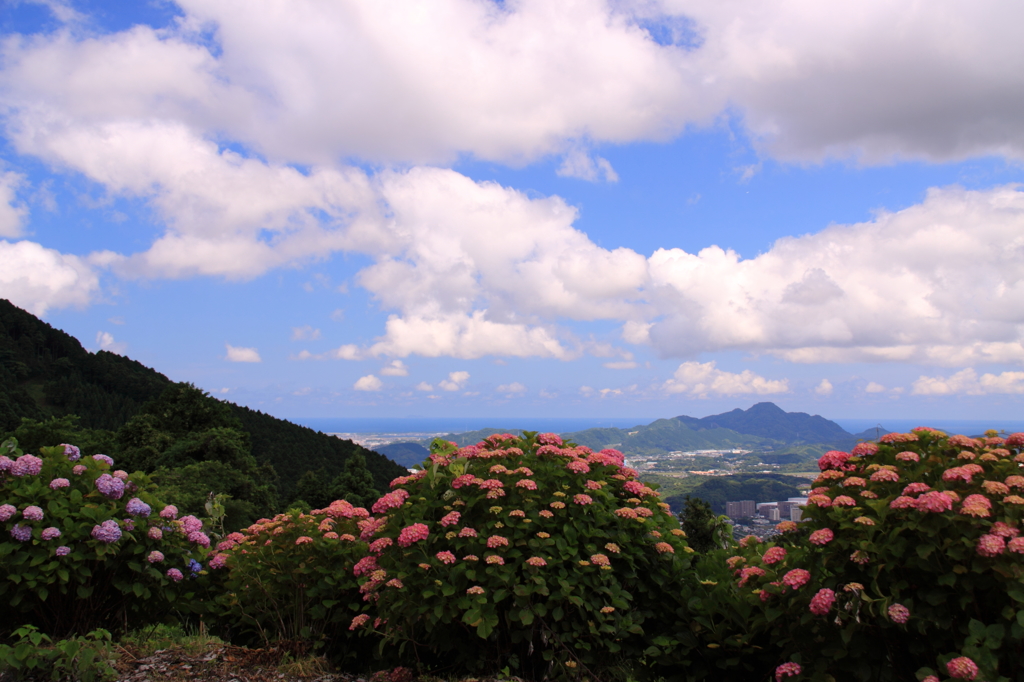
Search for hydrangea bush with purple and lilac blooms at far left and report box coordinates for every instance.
[0,439,210,637]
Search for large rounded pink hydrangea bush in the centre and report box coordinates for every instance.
[350,432,693,679]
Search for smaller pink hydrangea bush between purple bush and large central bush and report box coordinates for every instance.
[203,500,370,659]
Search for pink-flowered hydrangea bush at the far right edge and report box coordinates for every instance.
[727,428,1024,682]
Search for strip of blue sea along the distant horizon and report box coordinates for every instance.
[290,417,1024,435]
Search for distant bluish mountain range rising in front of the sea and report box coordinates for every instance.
[403,402,888,464]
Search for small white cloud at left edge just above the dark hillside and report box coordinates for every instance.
[0,240,99,315]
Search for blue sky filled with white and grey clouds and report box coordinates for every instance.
[0,0,1024,421]
